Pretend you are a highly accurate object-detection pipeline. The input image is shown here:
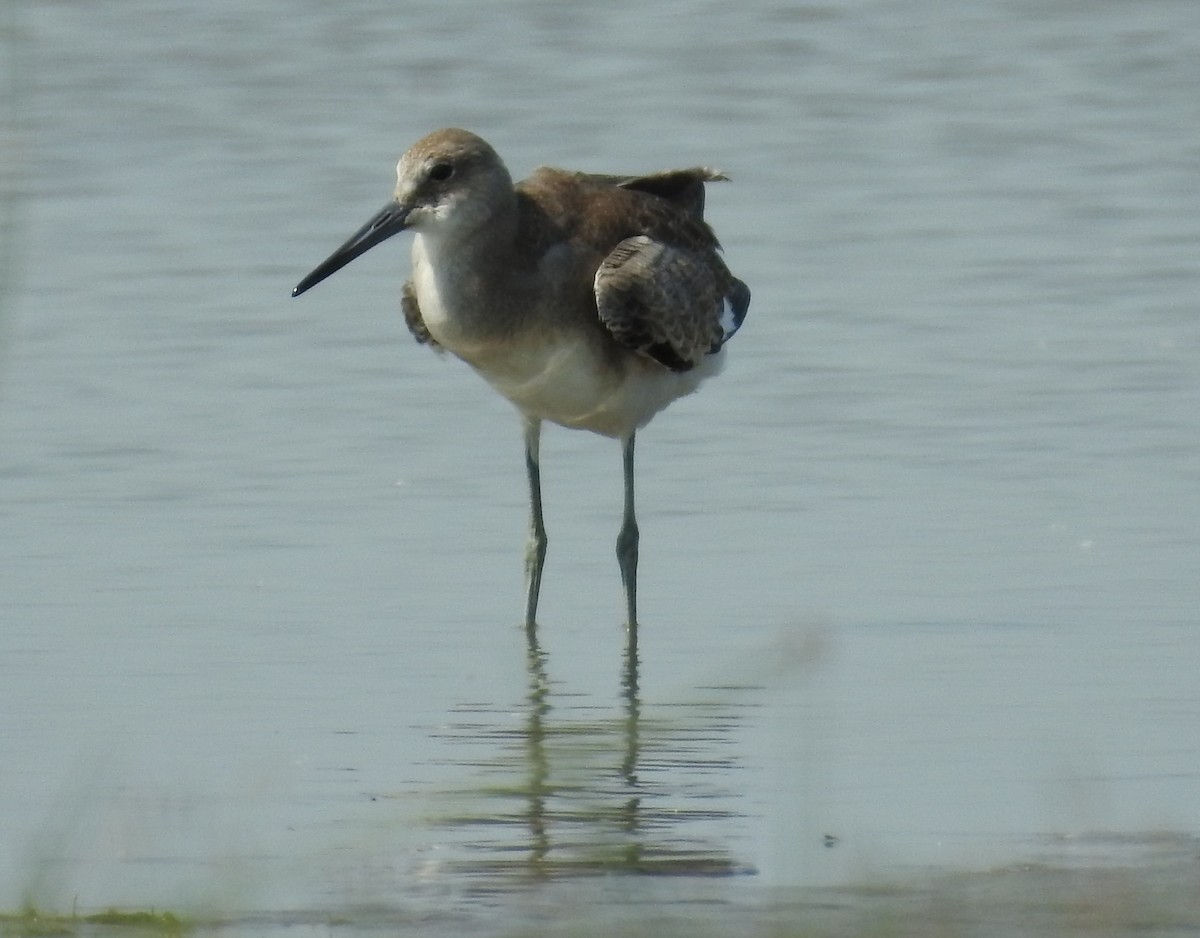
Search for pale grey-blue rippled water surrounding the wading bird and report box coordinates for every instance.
[0,0,1200,930]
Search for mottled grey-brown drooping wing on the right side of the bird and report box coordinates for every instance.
[595,235,750,372]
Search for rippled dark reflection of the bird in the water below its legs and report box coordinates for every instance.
[432,630,754,889]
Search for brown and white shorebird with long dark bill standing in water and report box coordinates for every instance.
[292,130,750,631]
